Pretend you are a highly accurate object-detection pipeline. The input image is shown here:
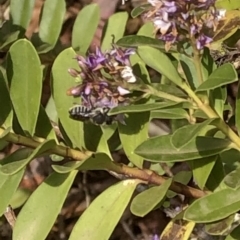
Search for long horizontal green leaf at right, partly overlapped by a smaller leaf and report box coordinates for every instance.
[135,135,231,162]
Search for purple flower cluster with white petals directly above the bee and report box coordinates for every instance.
[67,45,136,108]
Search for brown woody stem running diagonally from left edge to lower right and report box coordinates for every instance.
[0,127,208,198]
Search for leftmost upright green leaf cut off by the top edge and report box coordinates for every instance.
[10,0,35,29]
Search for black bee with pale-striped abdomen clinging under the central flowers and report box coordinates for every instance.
[69,105,114,125]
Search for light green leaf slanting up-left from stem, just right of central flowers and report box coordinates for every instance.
[138,46,182,87]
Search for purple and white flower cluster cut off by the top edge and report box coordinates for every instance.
[144,0,225,50]
